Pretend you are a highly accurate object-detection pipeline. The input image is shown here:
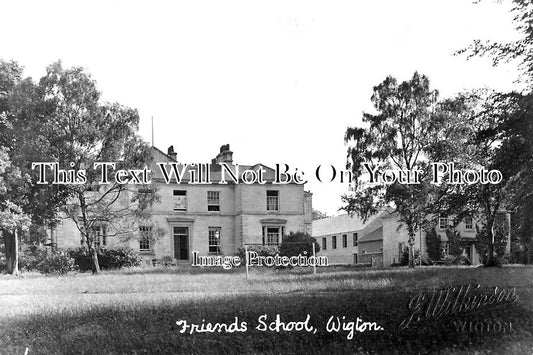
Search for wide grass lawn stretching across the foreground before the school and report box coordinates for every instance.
[0,266,533,355]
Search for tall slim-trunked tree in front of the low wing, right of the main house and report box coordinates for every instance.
[343,73,438,267]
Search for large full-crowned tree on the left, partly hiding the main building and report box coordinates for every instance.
[12,62,157,273]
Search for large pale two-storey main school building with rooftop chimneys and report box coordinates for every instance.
[50,144,312,262]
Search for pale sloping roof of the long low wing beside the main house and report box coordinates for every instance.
[313,211,387,237]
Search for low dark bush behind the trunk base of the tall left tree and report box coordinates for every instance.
[68,247,142,271]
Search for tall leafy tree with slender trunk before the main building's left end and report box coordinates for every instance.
[30,62,157,273]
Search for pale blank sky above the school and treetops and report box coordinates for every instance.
[0,0,518,215]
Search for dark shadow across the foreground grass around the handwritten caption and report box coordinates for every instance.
[0,291,533,355]
